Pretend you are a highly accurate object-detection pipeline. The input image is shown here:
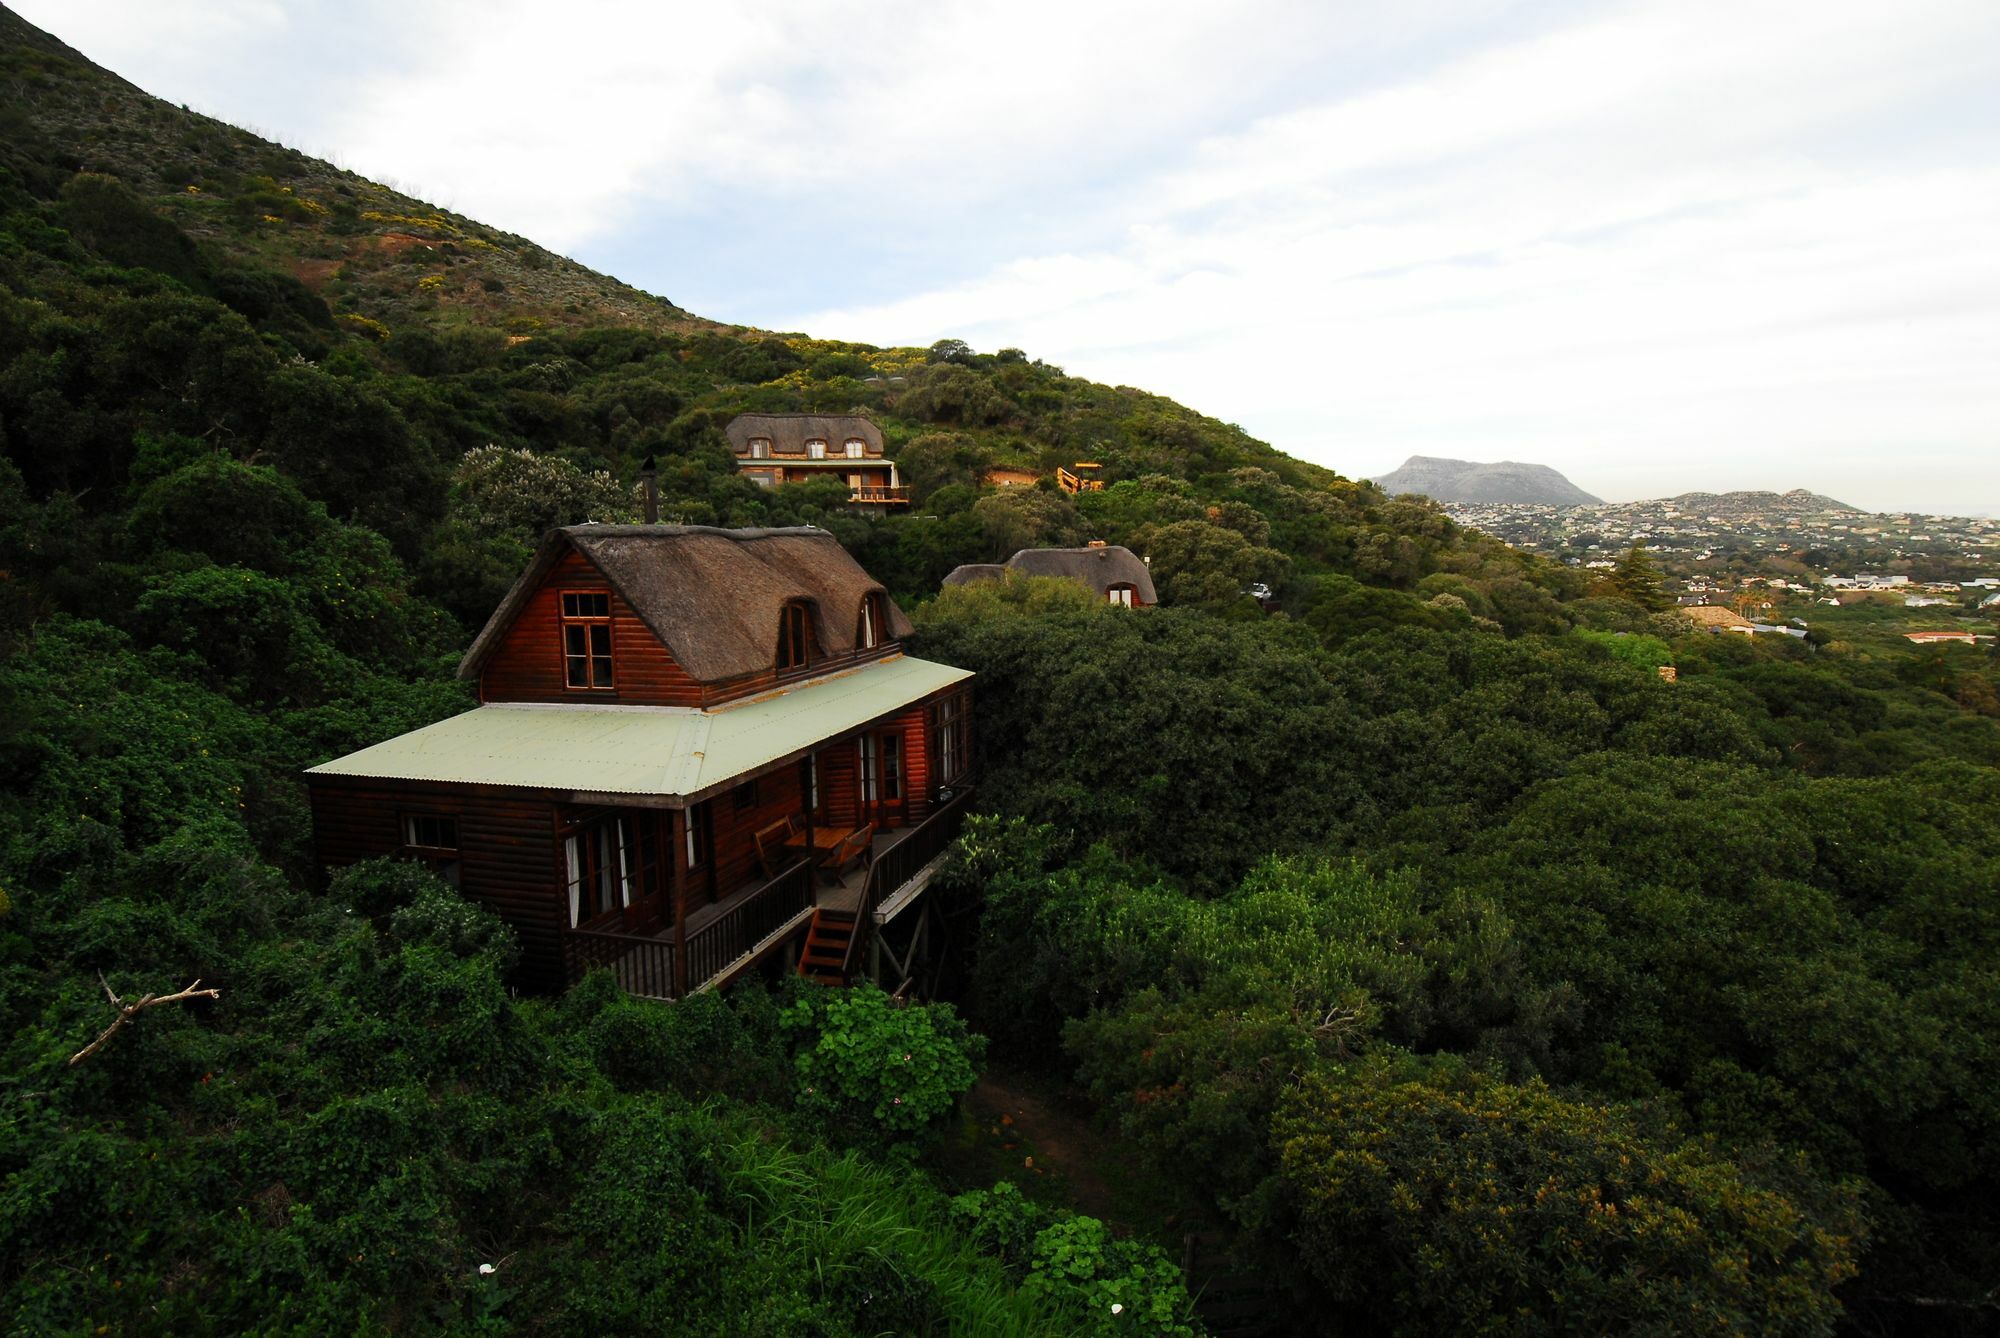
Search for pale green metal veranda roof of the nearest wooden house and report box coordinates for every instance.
[306,656,972,802]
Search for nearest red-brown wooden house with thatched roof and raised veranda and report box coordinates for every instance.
[306,524,972,998]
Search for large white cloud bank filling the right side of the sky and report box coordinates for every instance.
[780,4,2000,506]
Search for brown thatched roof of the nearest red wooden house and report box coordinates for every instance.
[458,524,910,682]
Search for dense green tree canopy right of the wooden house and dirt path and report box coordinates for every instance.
[920,590,2000,1332]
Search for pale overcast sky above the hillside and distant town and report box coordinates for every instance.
[27,0,2000,512]
